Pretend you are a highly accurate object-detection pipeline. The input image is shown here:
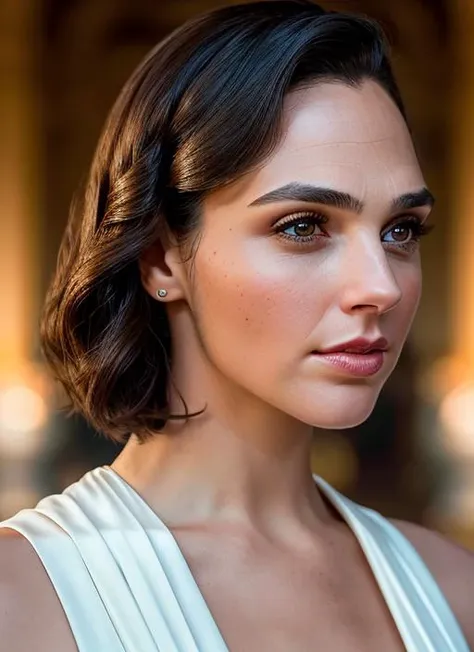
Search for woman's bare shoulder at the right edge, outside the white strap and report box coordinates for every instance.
[392,519,474,648]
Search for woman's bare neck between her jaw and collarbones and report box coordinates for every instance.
[112,308,329,537]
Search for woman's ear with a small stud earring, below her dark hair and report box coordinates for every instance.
[138,238,186,301]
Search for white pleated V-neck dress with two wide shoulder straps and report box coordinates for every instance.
[0,466,469,652]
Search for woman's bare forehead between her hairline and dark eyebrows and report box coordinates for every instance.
[242,81,424,204]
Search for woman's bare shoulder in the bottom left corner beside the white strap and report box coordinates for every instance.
[0,528,77,652]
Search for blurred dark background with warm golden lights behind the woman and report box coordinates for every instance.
[0,0,474,549]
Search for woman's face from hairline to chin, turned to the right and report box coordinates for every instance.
[185,81,431,428]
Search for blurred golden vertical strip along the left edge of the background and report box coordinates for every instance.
[0,0,41,376]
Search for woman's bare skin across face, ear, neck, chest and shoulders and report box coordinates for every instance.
[0,77,474,652]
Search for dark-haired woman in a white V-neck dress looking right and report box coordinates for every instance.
[0,0,474,652]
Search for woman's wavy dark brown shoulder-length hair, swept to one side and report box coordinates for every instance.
[41,0,405,440]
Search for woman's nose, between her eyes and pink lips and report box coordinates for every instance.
[341,233,402,315]
